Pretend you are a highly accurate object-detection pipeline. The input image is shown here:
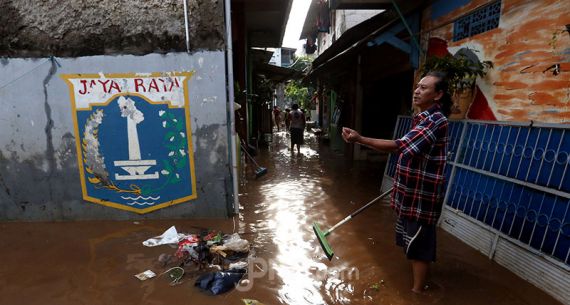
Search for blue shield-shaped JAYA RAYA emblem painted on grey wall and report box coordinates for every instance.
[61,72,197,214]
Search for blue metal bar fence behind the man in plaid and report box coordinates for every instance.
[385,116,570,264]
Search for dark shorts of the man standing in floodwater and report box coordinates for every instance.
[396,218,436,262]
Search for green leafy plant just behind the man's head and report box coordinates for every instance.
[420,53,493,96]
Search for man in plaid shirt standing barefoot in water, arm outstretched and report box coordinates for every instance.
[342,72,451,293]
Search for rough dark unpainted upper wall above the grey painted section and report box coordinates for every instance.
[0,0,224,57]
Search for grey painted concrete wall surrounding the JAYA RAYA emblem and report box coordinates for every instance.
[0,51,232,220]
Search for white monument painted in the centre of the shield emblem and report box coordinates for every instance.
[114,96,159,180]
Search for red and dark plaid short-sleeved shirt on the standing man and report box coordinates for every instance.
[391,104,448,224]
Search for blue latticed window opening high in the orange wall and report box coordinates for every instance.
[453,0,501,41]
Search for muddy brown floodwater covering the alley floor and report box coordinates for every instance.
[0,132,560,305]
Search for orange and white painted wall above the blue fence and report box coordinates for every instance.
[422,0,570,123]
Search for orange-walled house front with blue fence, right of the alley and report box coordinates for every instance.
[305,0,570,304]
